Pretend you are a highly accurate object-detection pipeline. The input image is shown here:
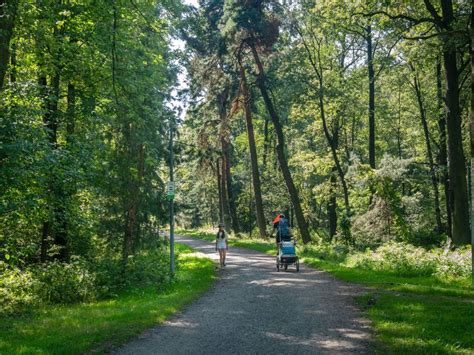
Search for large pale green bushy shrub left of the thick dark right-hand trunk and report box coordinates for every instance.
[347,155,443,250]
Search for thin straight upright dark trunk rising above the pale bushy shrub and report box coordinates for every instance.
[366,25,375,169]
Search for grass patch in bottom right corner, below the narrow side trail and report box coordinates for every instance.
[358,294,474,354]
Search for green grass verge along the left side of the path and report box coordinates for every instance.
[0,245,215,354]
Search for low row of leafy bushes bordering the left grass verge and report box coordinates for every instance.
[0,248,170,314]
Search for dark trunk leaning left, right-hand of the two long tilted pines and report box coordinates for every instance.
[250,43,311,243]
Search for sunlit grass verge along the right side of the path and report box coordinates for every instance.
[179,230,474,354]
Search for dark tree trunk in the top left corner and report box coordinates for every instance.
[0,0,18,91]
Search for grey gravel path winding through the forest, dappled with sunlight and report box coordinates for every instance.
[116,237,370,354]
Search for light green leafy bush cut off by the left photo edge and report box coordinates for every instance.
[0,262,40,314]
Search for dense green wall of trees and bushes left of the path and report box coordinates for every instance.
[0,0,182,312]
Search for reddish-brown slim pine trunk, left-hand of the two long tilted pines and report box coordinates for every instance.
[239,58,267,238]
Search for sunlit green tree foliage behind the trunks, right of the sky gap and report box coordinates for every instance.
[180,0,469,250]
